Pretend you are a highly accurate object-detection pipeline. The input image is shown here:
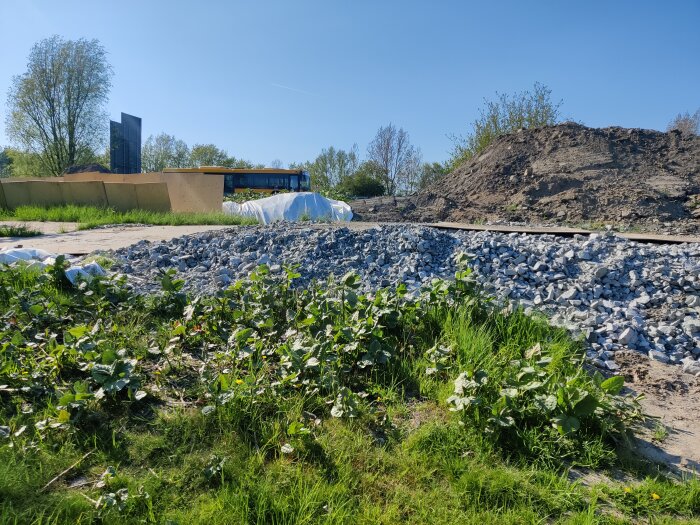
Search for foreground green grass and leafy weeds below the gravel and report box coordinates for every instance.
[0,261,700,525]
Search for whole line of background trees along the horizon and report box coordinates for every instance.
[0,36,700,196]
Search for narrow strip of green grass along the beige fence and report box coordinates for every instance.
[0,205,257,230]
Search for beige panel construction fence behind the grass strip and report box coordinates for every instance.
[0,172,224,212]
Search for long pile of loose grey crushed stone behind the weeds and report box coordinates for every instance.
[115,224,700,375]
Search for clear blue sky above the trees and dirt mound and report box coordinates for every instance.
[0,0,700,164]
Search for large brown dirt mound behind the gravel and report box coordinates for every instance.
[353,123,700,229]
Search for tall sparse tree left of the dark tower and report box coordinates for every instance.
[7,36,112,175]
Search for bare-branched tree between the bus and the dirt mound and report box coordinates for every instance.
[367,124,422,195]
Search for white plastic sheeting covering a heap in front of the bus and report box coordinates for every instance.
[223,192,352,224]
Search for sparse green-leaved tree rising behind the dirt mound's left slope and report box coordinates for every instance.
[448,82,562,170]
